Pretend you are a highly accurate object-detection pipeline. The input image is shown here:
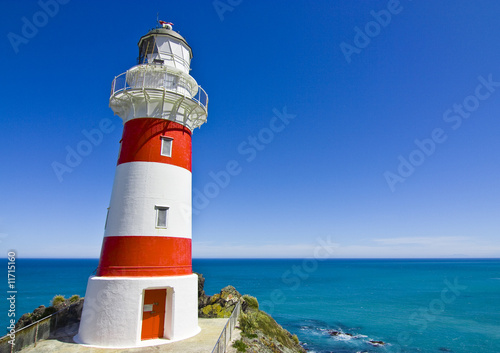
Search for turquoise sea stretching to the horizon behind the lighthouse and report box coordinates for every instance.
[0,259,500,353]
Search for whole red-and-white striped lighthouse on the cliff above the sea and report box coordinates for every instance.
[75,21,208,348]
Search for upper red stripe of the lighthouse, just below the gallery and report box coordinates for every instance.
[118,118,191,171]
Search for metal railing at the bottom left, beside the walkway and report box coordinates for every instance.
[0,306,75,353]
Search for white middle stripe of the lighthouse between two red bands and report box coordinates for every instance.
[104,162,191,239]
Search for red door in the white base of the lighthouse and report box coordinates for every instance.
[141,289,167,340]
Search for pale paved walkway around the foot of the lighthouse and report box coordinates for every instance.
[21,319,227,353]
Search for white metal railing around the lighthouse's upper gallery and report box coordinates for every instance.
[111,64,208,110]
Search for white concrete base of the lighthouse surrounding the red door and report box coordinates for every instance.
[74,274,200,348]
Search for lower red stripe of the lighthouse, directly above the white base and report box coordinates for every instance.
[97,236,193,277]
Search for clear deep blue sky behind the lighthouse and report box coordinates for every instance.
[0,0,500,258]
